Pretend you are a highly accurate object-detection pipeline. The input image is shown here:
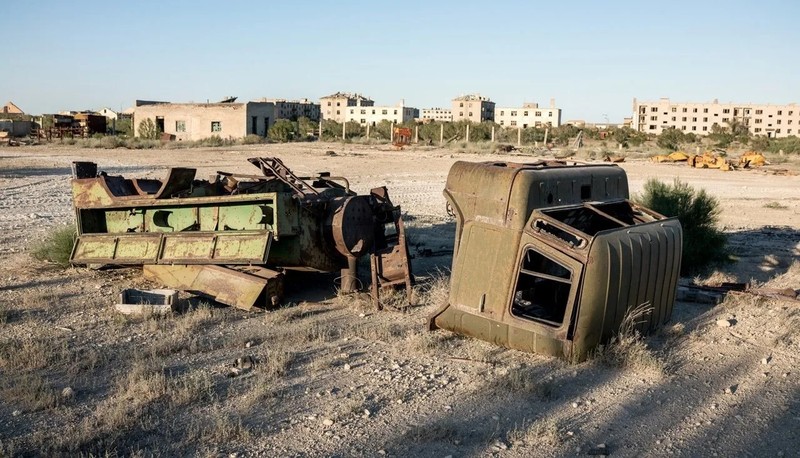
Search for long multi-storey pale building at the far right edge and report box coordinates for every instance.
[631,98,800,137]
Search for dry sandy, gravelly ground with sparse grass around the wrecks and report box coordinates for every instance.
[0,144,800,457]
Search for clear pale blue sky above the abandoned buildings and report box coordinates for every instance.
[0,0,800,122]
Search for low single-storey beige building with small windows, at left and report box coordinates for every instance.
[133,101,275,141]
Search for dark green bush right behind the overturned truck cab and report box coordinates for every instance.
[637,179,726,275]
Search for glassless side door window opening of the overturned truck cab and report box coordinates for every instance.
[511,248,572,326]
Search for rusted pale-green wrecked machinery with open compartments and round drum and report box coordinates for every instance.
[71,158,413,309]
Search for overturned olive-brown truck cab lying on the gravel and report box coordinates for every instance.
[429,161,683,362]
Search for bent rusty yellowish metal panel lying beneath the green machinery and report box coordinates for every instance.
[143,265,284,311]
